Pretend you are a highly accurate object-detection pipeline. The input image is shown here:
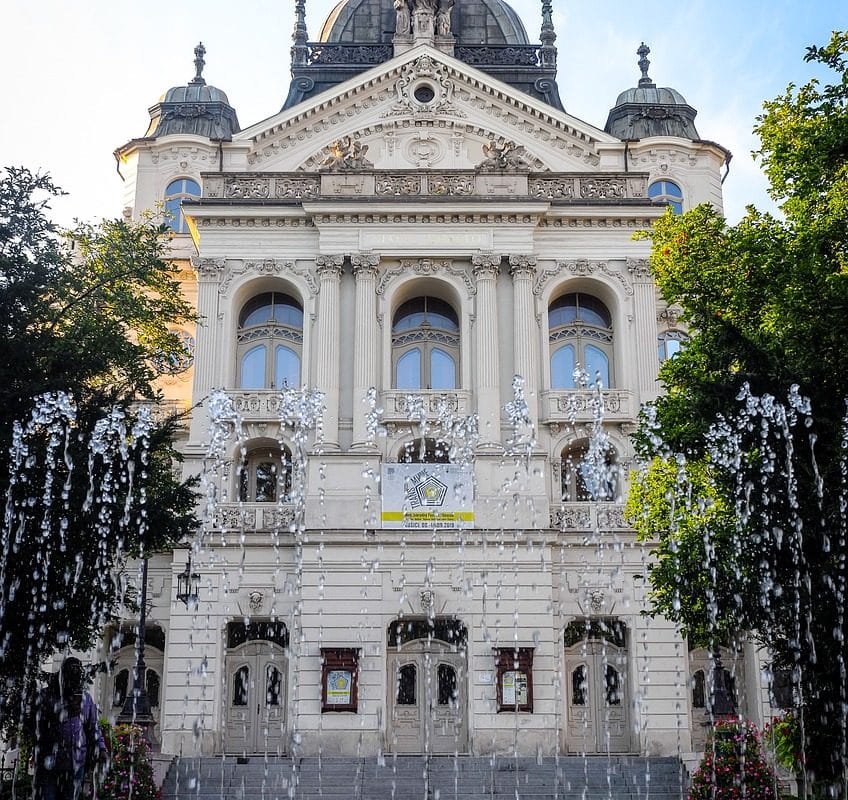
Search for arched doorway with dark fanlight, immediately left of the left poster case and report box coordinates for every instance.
[224,620,288,754]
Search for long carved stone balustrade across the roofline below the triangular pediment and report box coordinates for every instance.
[202,170,650,205]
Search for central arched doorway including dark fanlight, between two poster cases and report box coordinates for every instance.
[386,618,468,754]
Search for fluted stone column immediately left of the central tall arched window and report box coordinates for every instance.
[350,253,380,450]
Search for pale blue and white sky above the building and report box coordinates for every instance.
[0,0,848,224]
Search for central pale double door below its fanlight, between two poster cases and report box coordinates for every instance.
[388,640,468,754]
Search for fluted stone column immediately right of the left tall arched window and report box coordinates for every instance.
[314,255,344,450]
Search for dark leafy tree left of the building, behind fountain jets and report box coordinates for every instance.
[0,168,197,732]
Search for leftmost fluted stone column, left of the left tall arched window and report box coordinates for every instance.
[190,258,224,442]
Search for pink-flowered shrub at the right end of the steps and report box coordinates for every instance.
[689,719,777,800]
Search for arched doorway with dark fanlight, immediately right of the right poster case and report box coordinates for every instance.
[564,618,632,753]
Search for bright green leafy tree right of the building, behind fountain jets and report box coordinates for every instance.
[630,33,848,781]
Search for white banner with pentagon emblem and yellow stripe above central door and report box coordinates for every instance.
[381,464,474,530]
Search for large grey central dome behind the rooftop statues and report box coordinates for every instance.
[319,0,530,45]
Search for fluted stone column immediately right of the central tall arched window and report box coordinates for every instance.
[471,253,502,449]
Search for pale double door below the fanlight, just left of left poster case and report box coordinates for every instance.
[225,641,288,753]
